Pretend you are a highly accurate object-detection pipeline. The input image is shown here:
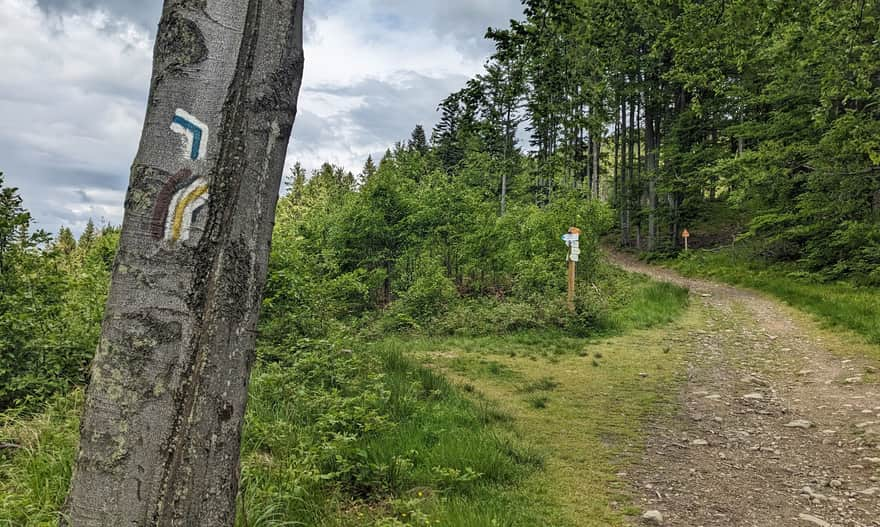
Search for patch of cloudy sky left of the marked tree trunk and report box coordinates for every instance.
[0,0,152,230]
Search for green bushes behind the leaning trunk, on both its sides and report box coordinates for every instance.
[0,143,612,408]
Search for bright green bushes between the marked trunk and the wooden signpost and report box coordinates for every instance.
[261,148,612,346]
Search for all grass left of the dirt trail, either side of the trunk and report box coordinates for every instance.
[0,275,687,527]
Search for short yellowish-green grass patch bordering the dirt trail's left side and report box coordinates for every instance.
[398,315,691,527]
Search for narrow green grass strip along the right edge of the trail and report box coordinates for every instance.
[667,251,880,344]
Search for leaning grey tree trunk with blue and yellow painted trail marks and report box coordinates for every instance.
[61,0,303,527]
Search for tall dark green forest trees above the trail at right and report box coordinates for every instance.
[446,0,880,284]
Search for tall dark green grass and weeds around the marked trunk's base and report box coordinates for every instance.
[0,344,551,527]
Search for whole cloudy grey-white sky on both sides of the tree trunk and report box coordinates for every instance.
[0,0,521,235]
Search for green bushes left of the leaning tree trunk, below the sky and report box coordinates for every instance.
[0,174,118,410]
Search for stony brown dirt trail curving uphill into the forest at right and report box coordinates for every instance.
[611,255,880,527]
